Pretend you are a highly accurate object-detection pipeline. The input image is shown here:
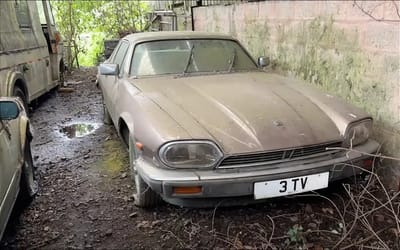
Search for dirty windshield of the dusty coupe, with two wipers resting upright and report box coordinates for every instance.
[130,39,257,77]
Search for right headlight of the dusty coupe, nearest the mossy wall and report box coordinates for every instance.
[345,120,372,147]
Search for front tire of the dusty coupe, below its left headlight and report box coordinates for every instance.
[128,135,161,208]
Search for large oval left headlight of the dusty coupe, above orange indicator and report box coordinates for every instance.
[158,141,222,168]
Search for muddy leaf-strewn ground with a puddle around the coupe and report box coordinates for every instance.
[0,69,400,249]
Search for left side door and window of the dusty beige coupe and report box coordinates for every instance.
[101,40,129,121]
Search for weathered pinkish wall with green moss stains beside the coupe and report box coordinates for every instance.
[193,1,400,188]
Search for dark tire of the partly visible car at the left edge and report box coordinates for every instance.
[20,140,38,203]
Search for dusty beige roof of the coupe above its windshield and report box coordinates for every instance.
[122,31,236,43]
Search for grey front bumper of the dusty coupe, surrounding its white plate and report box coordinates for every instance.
[135,140,379,204]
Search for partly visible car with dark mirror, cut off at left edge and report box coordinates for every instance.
[0,97,38,239]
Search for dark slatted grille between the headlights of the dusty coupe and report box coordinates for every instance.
[219,141,342,168]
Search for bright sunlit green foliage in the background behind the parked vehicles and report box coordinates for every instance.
[51,0,149,67]
